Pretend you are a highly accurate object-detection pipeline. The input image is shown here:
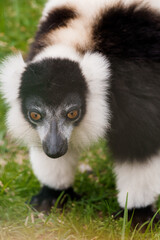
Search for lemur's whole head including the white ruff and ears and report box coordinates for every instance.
[1,46,108,158]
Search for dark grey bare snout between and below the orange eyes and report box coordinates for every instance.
[43,121,68,158]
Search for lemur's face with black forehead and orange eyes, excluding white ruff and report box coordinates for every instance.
[19,59,87,158]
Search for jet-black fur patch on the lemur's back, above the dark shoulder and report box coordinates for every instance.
[93,4,160,60]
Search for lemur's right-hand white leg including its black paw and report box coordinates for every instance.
[115,156,160,226]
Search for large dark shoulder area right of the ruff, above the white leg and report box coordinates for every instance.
[107,59,160,161]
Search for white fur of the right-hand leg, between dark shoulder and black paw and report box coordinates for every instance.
[115,155,160,209]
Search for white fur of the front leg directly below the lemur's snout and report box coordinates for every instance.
[30,147,78,189]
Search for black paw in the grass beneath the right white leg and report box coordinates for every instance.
[114,205,160,231]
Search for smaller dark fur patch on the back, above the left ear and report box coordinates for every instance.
[28,7,77,61]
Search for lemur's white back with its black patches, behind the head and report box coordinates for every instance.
[29,0,160,60]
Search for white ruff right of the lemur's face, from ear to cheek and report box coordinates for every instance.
[72,53,110,147]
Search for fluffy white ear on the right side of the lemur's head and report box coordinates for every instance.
[80,52,110,91]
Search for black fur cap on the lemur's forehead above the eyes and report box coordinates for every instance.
[19,59,87,125]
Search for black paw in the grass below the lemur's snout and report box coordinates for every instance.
[30,186,80,214]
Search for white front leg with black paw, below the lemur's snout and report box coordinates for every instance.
[30,148,80,213]
